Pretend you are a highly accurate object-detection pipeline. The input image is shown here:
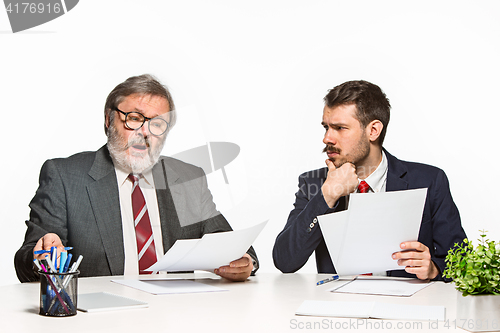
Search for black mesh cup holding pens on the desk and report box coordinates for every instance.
[38,271,80,317]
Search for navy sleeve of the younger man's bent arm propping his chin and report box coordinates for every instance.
[273,174,338,273]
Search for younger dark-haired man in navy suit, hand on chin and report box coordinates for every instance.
[273,81,466,279]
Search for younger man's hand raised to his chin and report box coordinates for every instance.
[321,160,358,208]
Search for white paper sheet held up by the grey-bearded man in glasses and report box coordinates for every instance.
[147,221,267,272]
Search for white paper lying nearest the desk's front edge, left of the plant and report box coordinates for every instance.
[295,300,446,321]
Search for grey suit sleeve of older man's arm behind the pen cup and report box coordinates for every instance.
[14,160,67,282]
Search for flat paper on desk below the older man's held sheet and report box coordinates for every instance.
[111,279,227,295]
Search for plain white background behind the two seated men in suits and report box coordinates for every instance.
[0,0,500,285]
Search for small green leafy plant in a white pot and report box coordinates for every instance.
[443,230,500,332]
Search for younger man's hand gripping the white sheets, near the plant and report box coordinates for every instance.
[392,242,439,280]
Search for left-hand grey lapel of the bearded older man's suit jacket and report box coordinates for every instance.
[87,146,125,275]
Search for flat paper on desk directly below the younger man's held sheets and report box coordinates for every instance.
[329,278,434,297]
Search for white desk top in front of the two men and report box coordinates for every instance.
[0,273,465,333]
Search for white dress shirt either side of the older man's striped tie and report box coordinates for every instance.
[115,167,163,275]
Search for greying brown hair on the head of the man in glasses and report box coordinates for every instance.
[104,74,177,134]
